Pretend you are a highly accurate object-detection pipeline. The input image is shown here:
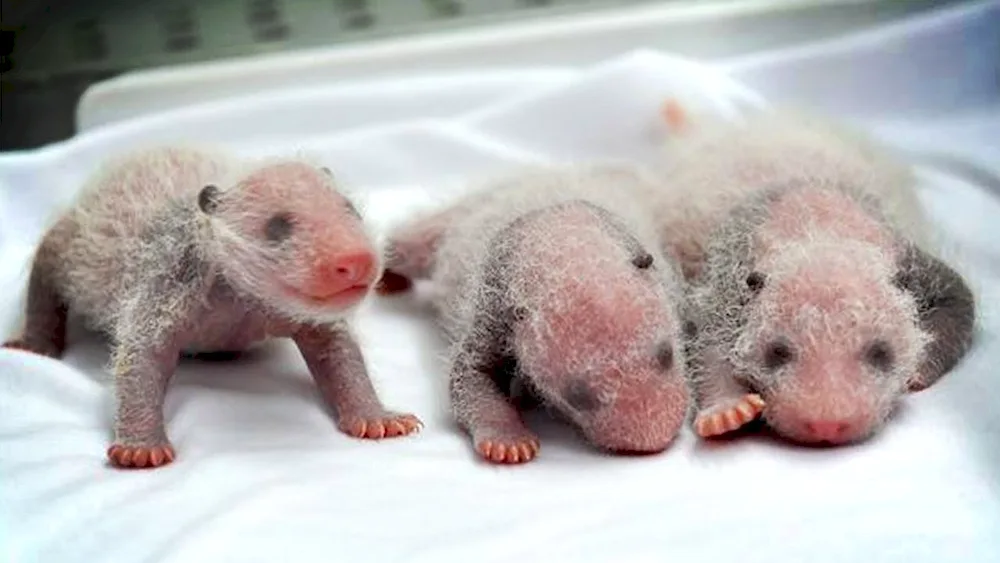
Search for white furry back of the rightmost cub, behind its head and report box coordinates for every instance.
[653,107,930,275]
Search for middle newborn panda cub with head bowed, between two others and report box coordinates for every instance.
[382,165,688,463]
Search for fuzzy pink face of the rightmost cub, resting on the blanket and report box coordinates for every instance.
[747,254,921,444]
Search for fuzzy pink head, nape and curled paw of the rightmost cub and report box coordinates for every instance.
[695,190,926,444]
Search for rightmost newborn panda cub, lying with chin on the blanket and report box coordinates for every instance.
[660,108,975,444]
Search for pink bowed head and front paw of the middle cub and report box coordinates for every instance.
[482,208,688,453]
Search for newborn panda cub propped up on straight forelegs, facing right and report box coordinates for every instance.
[5,148,419,467]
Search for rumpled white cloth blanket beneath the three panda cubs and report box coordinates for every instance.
[0,29,1000,563]
